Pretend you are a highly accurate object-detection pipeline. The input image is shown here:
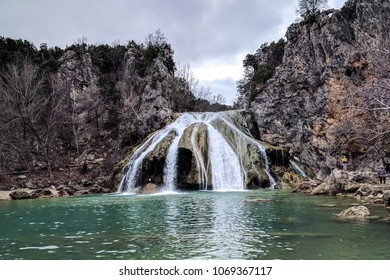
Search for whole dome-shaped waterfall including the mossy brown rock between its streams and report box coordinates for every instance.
[118,111,276,192]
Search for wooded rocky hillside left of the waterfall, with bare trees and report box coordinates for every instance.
[0,31,227,192]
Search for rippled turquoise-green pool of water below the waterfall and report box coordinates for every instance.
[0,190,390,260]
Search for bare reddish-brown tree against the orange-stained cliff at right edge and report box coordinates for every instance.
[330,35,390,166]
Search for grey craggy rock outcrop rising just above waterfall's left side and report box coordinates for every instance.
[116,49,179,142]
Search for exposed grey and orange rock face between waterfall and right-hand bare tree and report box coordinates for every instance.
[249,0,390,179]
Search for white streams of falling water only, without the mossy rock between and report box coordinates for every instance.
[118,112,276,193]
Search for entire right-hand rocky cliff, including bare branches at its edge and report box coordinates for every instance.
[249,0,390,179]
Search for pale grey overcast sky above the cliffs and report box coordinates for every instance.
[0,0,346,104]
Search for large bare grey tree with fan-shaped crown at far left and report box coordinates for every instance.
[0,59,63,177]
